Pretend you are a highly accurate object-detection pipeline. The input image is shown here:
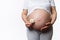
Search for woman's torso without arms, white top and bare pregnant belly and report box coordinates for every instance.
[28,0,51,30]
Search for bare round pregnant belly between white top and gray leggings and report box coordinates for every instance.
[28,9,51,30]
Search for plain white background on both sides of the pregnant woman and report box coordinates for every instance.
[0,0,60,40]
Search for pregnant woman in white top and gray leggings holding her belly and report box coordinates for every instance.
[22,0,57,40]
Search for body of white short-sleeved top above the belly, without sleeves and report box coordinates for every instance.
[28,0,51,15]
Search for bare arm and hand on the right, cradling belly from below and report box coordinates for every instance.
[41,7,57,30]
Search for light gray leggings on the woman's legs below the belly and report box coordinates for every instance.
[27,28,53,40]
